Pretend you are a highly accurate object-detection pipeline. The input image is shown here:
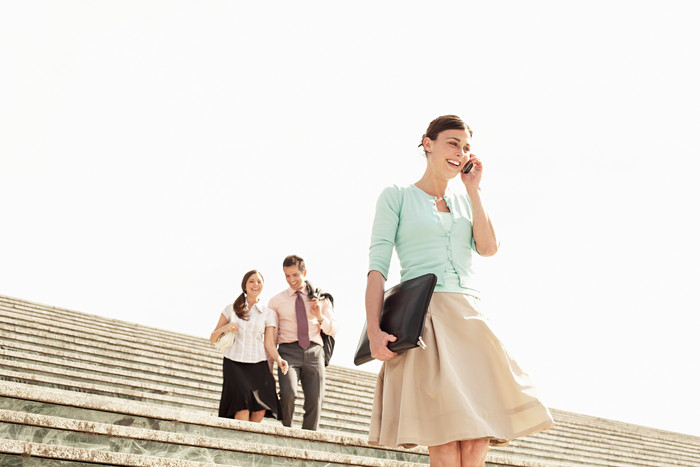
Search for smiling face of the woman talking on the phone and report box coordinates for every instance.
[423,130,471,179]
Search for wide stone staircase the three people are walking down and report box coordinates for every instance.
[0,295,700,467]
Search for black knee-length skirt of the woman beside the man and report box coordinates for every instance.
[219,357,280,418]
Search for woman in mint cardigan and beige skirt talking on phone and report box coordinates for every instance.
[365,115,553,466]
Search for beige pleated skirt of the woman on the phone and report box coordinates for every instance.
[368,292,554,448]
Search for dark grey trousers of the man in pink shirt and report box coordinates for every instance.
[278,342,326,430]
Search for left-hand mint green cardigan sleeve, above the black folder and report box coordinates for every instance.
[369,185,401,279]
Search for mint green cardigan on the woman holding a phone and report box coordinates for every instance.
[369,185,479,297]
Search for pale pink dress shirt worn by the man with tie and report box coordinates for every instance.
[267,284,337,346]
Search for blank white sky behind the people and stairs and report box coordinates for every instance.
[0,0,700,435]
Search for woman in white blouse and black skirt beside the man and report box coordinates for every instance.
[209,270,288,422]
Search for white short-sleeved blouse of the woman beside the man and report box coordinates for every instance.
[221,301,277,363]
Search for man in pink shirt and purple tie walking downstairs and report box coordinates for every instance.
[267,255,337,430]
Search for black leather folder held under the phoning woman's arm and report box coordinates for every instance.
[355,274,437,365]
